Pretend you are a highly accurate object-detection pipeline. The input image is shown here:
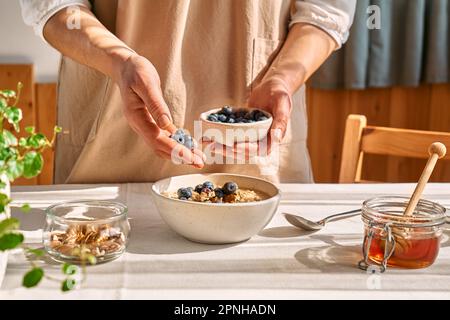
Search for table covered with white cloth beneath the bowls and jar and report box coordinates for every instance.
[0,184,450,299]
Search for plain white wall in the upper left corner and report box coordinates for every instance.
[0,0,60,82]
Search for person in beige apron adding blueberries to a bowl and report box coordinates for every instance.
[21,0,356,183]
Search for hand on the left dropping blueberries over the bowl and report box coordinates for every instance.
[114,54,204,168]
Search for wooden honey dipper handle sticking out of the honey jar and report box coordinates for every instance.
[404,142,447,216]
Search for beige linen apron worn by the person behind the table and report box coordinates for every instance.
[55,0,312,183]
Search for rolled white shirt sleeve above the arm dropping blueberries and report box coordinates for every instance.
[20,0,91,41]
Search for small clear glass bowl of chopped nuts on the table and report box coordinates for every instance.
[43,200,130,264]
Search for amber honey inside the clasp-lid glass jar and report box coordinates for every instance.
[364,232,440,269]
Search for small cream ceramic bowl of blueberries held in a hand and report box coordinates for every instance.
[200,107,273,146]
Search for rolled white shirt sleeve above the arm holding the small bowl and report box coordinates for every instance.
[290,0,356,48]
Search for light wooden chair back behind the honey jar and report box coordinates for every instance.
[339,114,450,183]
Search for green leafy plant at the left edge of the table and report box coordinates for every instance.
[0,83,80,291]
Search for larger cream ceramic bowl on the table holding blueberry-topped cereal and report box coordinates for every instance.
[152,173,281,244]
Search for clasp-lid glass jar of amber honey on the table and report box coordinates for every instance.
[359,196,446,272]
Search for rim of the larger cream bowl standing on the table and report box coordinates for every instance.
[151,172,281,207]
